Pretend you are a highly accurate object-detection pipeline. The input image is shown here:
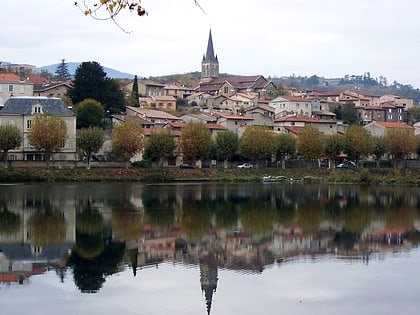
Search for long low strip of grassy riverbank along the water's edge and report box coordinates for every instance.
[0,168,420,185]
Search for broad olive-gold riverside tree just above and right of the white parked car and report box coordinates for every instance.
[239,126,276,165]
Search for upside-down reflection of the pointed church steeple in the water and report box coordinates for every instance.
[200,254,218,315]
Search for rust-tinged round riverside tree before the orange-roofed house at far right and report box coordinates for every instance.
[386,129,417,159]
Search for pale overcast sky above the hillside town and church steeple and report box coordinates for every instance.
[0,0,420,88]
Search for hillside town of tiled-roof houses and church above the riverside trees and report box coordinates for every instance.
[0,30,420,167]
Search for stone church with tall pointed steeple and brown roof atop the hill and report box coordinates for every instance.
[197,29,277,99]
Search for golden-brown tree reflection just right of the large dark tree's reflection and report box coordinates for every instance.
[112,205,143,241]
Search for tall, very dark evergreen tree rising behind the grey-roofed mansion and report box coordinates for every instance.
[68,61,125,113]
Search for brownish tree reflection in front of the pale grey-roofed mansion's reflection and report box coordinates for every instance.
[28,202,66,245]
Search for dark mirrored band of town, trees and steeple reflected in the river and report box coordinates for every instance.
[0,183,420,314]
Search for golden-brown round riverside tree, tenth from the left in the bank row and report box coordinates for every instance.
[297,125,324,165]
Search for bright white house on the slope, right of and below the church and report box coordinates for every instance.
[268,95,312,117]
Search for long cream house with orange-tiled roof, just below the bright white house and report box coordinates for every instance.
[274,116,338,135]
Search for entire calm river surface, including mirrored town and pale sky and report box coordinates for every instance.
[0,183,420,315]
